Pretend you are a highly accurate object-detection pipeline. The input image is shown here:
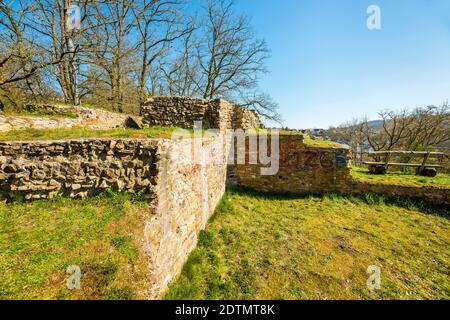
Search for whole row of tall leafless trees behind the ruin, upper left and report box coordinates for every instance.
[0,0,279,120]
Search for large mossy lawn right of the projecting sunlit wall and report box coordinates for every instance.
[165,191,450,299]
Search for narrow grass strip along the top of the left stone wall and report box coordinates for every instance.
[0,126,175,141]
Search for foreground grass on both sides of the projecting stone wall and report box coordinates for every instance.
[0,185,450,299]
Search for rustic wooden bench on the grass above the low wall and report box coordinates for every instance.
[363,151,446,177]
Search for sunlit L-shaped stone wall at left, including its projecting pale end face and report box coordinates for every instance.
[0,135,228,298]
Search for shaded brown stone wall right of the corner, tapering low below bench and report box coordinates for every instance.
[227,135,450,205]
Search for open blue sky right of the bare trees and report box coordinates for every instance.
[232,0,450,128]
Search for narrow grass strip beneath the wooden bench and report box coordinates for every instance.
[352,167,450,189]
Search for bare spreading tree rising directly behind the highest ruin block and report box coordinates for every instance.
[196,0,269,99]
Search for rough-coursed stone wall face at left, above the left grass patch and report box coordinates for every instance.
[0,139,157,200]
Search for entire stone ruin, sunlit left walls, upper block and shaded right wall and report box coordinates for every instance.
[0,98,449,298]
